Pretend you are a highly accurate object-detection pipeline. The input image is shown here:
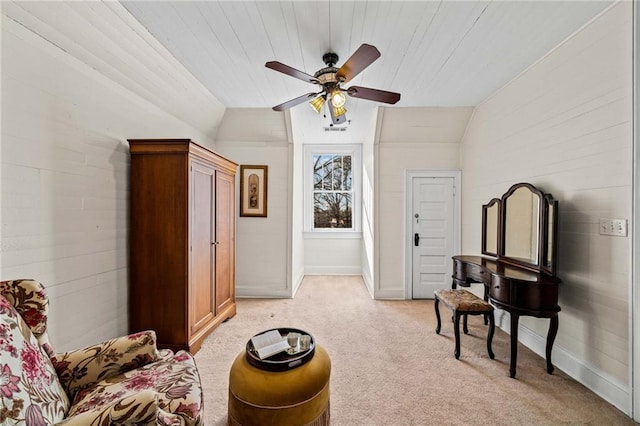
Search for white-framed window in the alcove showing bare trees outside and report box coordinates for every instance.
[305,145,361,233]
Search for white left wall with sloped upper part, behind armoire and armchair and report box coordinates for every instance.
[0,2,224,351]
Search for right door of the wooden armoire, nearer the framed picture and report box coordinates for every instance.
[215,171,235,313]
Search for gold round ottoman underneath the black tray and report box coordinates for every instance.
[228,345,331,426]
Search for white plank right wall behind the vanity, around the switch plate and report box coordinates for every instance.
[462,2,633,412]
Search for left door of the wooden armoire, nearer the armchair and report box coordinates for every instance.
[189,161,216,335]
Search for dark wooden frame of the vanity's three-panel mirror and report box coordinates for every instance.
[482,183,558,276]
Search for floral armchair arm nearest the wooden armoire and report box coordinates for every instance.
[51,330,159,400]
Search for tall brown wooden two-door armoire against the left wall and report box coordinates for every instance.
[129,139,237,353]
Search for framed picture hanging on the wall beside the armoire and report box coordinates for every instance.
[240,165,269,217]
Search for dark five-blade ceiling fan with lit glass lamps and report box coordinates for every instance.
[264,44,400,124]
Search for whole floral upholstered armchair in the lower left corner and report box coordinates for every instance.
[0,280,203,426]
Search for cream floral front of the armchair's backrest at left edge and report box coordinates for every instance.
[0,295,69,426]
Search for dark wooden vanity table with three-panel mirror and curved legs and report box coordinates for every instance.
[452,183,561,377]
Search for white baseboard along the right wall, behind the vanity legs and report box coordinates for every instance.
[496,310,631,416]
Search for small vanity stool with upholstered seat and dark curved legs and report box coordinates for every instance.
[433,289,495,359]
